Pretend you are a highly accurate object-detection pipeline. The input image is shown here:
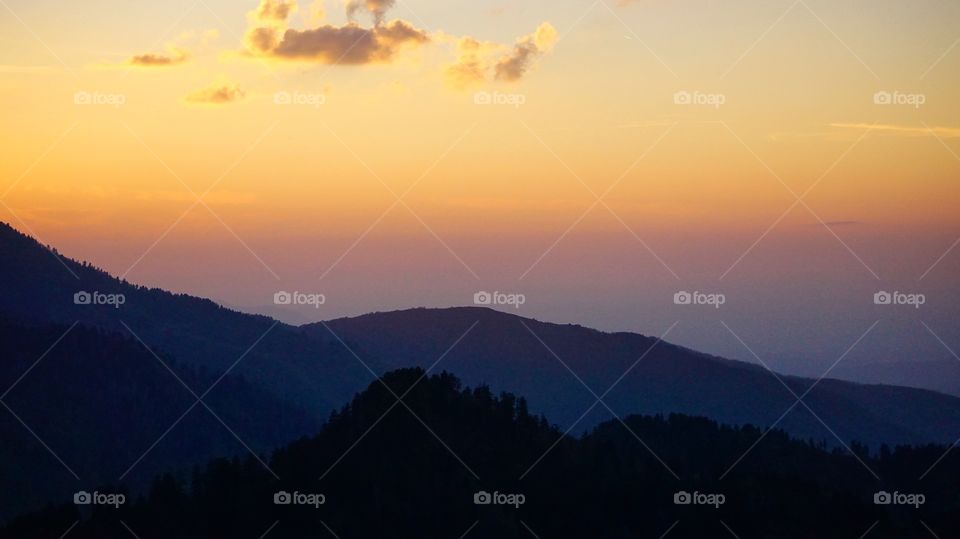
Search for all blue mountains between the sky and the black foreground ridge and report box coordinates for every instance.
[0,221,960,517]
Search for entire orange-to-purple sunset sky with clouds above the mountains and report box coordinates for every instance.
[0,0,960,374]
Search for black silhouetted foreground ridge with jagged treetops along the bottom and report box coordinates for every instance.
[0,369,960,539]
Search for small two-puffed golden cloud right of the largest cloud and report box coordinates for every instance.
[445,22,557,88]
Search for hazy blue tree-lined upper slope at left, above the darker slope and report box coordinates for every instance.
[0,224,373,420]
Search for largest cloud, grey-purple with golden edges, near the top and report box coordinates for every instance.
[246,0,430,65]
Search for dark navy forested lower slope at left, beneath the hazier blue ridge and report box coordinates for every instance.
[0,318,321,516]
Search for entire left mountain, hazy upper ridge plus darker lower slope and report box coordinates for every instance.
[0,224,374,519]
